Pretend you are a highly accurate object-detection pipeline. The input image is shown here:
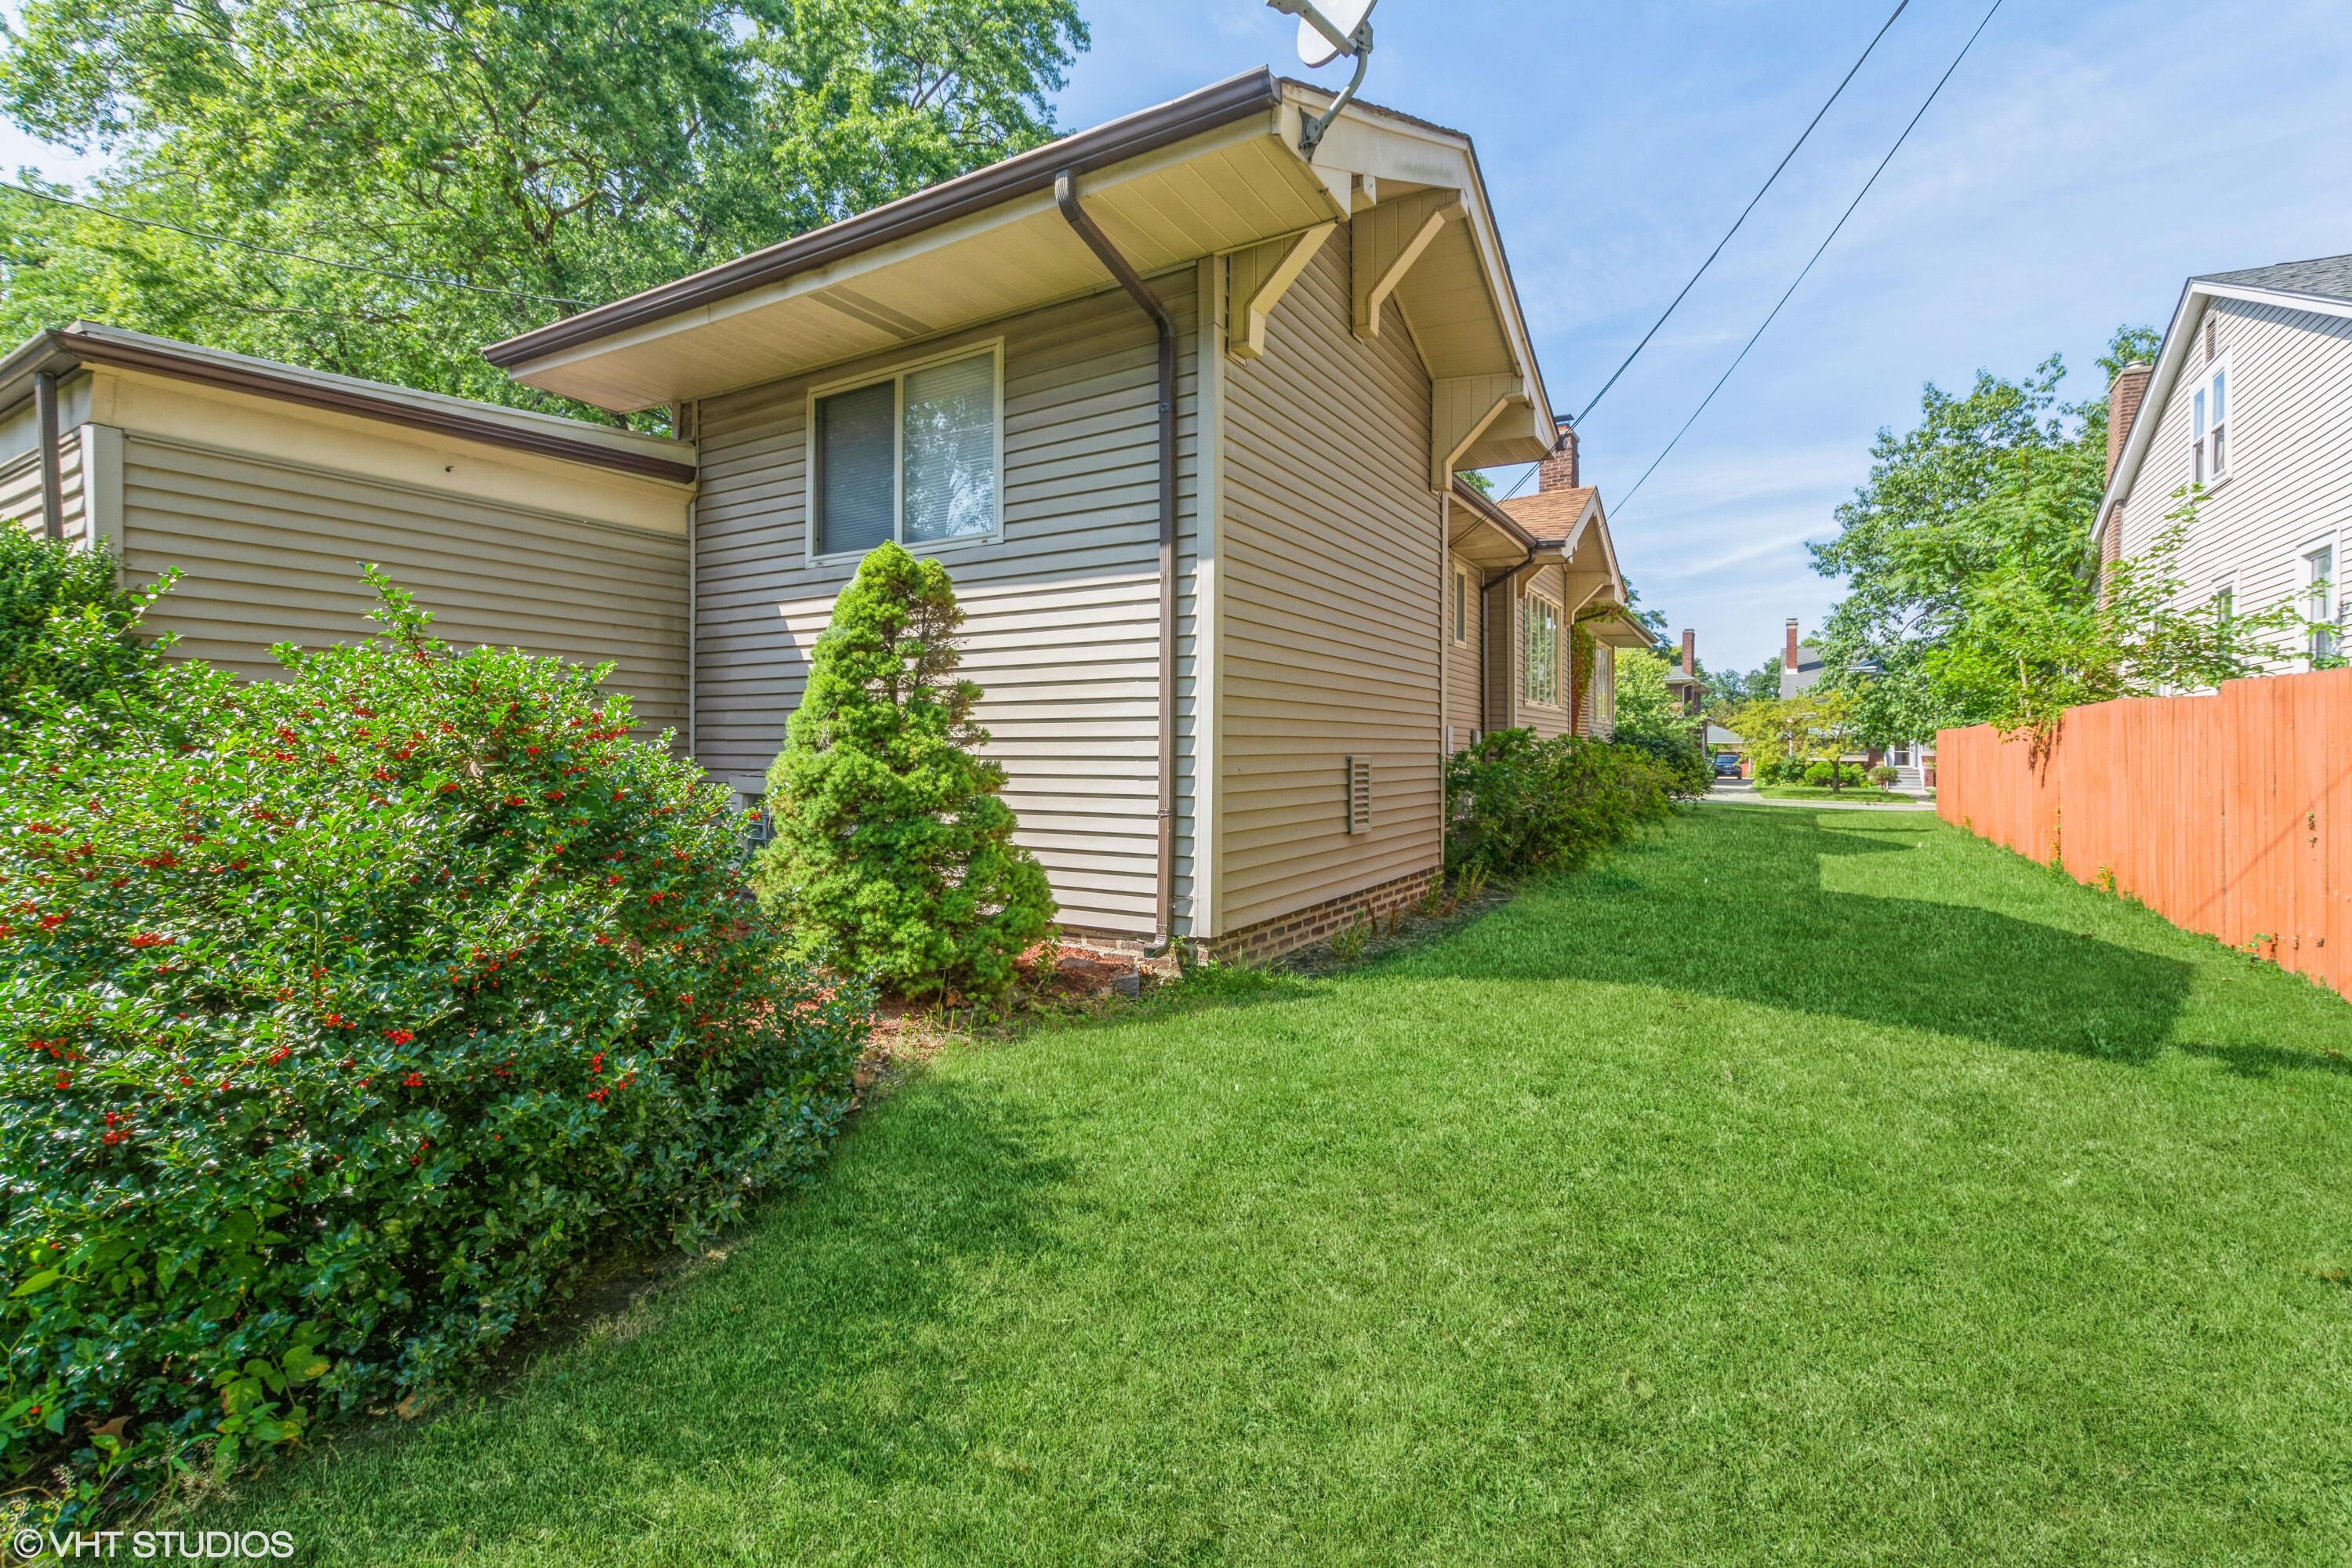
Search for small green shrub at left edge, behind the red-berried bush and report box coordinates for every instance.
[0,517,169,743]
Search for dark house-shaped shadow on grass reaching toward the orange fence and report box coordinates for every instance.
[1374,806,2201,1065]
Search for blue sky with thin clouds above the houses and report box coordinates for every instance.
[0,0,2352,668]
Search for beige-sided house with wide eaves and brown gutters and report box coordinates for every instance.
[0,71,1646,952]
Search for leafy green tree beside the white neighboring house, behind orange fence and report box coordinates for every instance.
[1811,327,2157,743]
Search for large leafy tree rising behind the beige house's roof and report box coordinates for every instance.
[0,0,1087,420]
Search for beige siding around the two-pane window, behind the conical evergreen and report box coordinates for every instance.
[694,270,1197,933]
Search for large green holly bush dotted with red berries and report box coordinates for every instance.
[0,574,866,1514]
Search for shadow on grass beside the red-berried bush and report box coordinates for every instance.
[212,1076,1073,1556]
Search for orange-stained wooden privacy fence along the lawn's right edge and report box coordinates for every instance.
[1936,670,2352,994]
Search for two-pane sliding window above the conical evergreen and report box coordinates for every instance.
[809,343,1004,555]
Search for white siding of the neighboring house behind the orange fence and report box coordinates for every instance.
[2122,299,2352,670]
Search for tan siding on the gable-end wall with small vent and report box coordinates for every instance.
[1218,245,1444,931]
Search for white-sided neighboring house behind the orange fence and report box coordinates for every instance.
[2096,256,2352,673]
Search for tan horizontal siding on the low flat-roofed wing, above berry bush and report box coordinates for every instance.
[122,435,687,731]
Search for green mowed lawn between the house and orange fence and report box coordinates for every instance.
[198,806,2352,1568]
